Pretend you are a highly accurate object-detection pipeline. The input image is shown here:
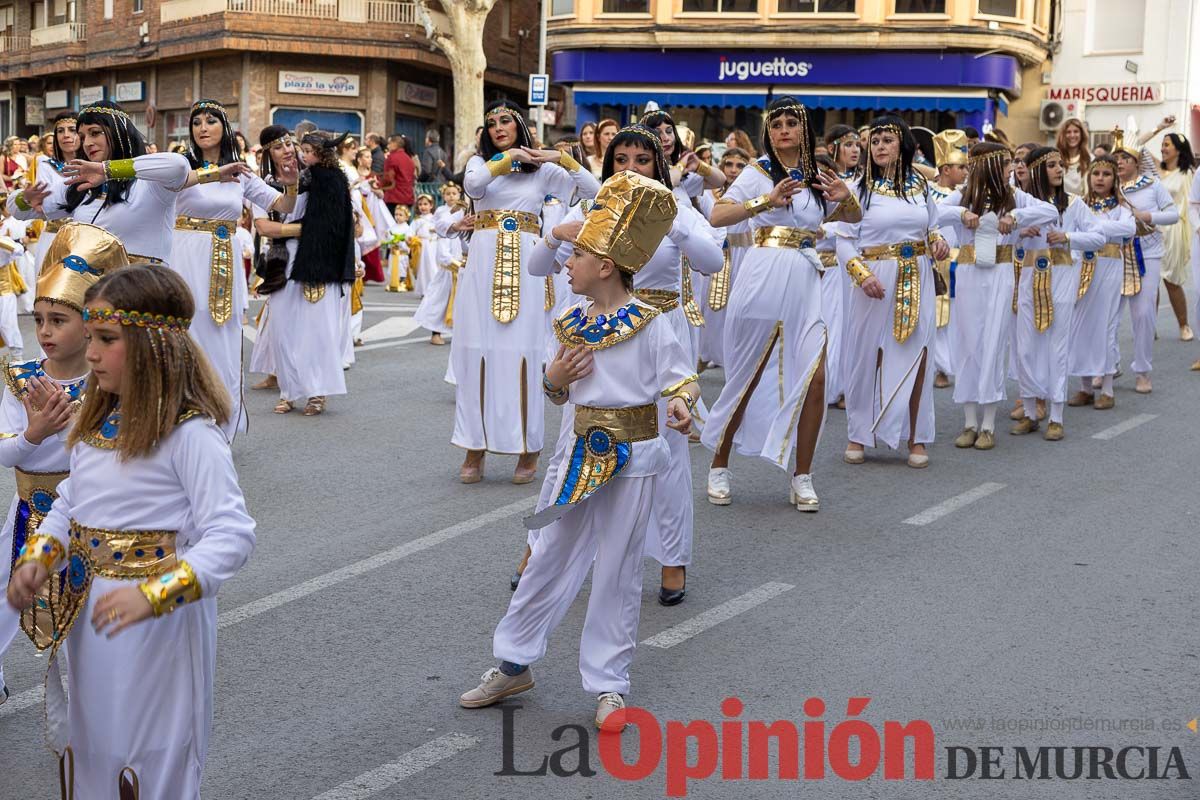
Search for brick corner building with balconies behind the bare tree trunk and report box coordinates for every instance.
[0,0,539,148]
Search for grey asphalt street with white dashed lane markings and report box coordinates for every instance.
[0,287,1200,800]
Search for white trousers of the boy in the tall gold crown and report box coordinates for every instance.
[492,476,654,694]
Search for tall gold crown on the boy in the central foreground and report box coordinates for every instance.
[575,172,678,275]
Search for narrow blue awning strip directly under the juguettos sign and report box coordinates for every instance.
[575,85,1008,114]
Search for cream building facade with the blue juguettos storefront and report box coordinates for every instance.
[547,0,1055,140]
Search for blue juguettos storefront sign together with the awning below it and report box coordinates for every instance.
[553,50,1020,126]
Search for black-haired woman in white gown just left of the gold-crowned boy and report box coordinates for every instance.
[451,101,599,483]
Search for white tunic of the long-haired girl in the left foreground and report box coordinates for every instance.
[38,417,254,800]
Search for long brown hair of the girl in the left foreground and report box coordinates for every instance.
[67,264,230,461]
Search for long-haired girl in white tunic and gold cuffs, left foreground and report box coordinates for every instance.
[7,265,254,800]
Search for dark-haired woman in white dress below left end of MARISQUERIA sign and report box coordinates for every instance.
[1009,148,1105,441]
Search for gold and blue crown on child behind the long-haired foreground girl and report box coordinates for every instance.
[37,222,130,312]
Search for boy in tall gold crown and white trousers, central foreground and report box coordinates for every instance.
[460,172,700,726]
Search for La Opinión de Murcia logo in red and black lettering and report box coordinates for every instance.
[494,697,1190,798]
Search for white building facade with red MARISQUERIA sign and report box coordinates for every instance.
[1045,0,1200,152]
